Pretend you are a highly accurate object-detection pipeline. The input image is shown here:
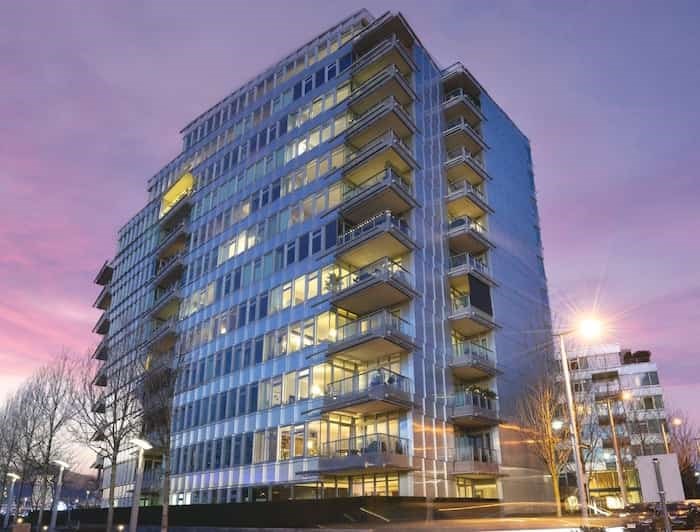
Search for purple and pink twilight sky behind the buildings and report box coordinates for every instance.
[0,0,700,422]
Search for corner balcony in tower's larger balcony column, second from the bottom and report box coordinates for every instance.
[321,368,413,416]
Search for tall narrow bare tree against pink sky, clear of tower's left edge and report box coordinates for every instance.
[33,353,75,530]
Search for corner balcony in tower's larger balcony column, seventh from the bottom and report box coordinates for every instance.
[343,131,418,183]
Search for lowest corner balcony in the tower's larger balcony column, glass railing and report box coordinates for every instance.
[319,434,411,475]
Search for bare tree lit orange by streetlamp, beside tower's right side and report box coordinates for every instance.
[518,375,571,517]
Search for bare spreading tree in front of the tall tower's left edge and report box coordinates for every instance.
[70,359,141,532]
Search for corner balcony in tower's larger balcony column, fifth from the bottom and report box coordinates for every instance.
[336,211,416,268]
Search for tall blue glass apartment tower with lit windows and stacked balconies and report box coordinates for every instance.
[95,10,551,504]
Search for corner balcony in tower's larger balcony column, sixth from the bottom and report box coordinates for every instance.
[340,167,418,223]
